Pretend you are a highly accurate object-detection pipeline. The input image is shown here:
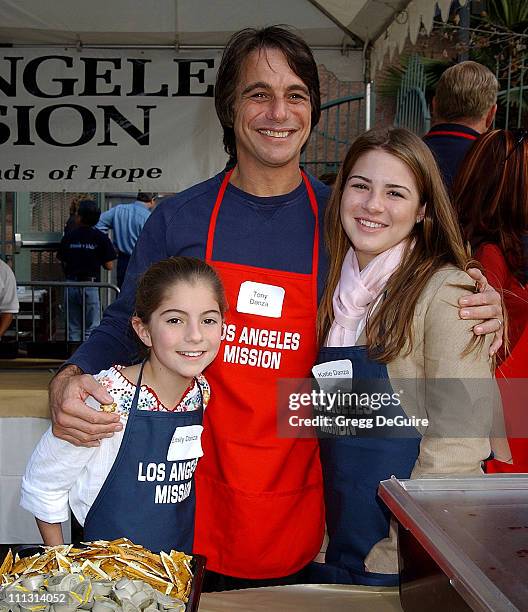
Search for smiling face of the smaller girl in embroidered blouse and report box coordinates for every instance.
[132,281,222,379]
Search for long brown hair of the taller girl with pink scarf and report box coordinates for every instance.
[317,128,469,363]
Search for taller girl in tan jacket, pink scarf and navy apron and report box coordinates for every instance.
[310,129,510,586]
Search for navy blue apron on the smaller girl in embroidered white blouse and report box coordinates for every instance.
[84,364,203,553]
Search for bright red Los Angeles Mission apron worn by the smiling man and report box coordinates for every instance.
[194,172,324,579]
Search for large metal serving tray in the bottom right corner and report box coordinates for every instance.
[379,474,528,612]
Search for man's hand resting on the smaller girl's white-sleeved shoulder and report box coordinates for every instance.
[49,365,123,446]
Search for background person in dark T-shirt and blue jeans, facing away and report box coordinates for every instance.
[57,200,116,342]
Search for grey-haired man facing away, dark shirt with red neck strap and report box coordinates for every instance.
[424,62,499,191]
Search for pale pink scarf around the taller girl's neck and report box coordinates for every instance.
[325,240,407,346]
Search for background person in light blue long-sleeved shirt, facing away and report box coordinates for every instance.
[96,191,156,289]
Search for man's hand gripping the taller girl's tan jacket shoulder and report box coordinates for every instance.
[458,268,504,355]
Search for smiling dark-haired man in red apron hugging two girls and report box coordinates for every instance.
[50,27,500,590]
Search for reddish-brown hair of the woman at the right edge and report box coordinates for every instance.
[453,130,528,284]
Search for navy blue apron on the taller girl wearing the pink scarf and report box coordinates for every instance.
[309,346,420,586]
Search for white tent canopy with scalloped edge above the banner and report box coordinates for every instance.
[0,0,465,73]
